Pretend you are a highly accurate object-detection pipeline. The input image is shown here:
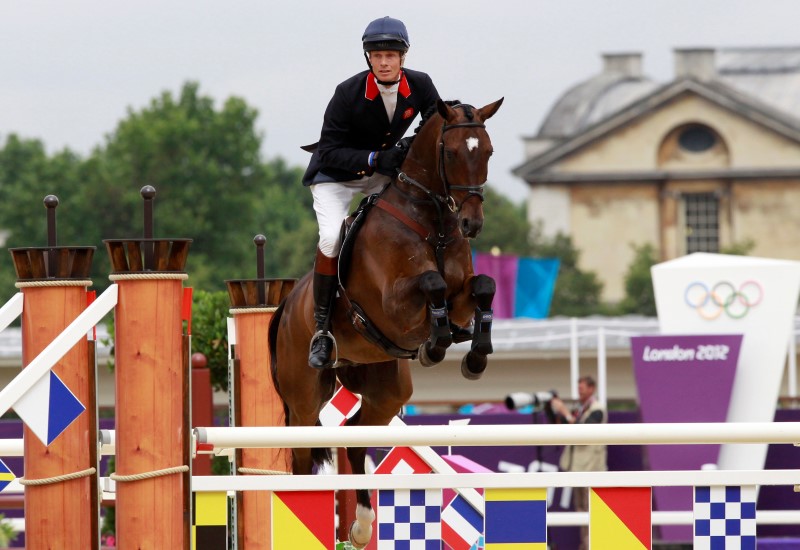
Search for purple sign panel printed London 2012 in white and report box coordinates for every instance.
[631,334,742,540]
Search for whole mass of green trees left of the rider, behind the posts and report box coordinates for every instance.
[0,83,316,299]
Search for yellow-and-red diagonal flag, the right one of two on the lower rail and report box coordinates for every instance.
[589,487,653,550]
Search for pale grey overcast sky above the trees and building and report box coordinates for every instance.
[0,0,800,202]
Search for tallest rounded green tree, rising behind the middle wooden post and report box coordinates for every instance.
[88,82,265,290]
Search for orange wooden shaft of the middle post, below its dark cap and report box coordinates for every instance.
[114,279,189,550]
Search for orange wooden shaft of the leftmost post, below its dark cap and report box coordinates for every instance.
[22,286,98,550]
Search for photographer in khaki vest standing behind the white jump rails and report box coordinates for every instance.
[550,376,608,550]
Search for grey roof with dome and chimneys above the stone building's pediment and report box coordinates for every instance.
[513,47,800,181]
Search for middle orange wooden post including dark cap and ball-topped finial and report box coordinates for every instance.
[104,186,191,550]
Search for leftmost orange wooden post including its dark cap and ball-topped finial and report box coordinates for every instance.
[10,195,99,550]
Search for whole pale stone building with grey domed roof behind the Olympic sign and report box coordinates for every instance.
[514,47,800,301]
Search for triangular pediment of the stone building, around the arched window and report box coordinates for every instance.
[514,77,800,183]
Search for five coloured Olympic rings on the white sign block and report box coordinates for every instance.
[683,280,764,321]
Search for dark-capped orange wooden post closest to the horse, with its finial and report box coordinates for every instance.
[225,235,295,550]
